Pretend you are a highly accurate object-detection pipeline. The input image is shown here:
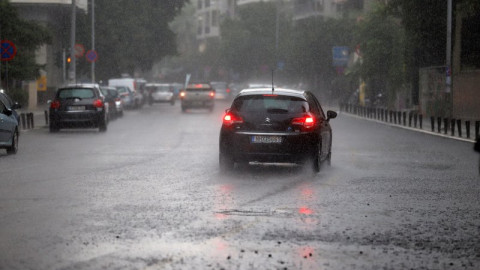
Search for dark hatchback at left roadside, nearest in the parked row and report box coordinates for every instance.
[49,84,108,132]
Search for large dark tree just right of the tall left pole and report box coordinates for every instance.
[95,0,187,80]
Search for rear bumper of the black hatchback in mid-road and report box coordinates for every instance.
[220,132,319,163]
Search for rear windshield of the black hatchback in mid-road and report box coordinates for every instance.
[232,95,309,114]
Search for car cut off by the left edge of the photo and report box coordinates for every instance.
[0,95,20,155]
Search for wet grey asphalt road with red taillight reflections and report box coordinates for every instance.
[0,103,480,269]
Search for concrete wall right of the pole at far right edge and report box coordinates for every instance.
[453,70,480,121]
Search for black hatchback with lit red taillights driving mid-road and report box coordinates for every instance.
[219,88,337,172]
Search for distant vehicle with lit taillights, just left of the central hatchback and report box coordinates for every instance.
[180,83,215,112]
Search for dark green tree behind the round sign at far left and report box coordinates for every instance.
[0,0,51,88]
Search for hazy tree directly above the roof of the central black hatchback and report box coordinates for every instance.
[221,2,290,80]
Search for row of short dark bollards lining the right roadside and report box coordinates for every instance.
[340,103,480,139]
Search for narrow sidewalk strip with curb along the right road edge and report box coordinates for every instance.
[340,111,476,143]
